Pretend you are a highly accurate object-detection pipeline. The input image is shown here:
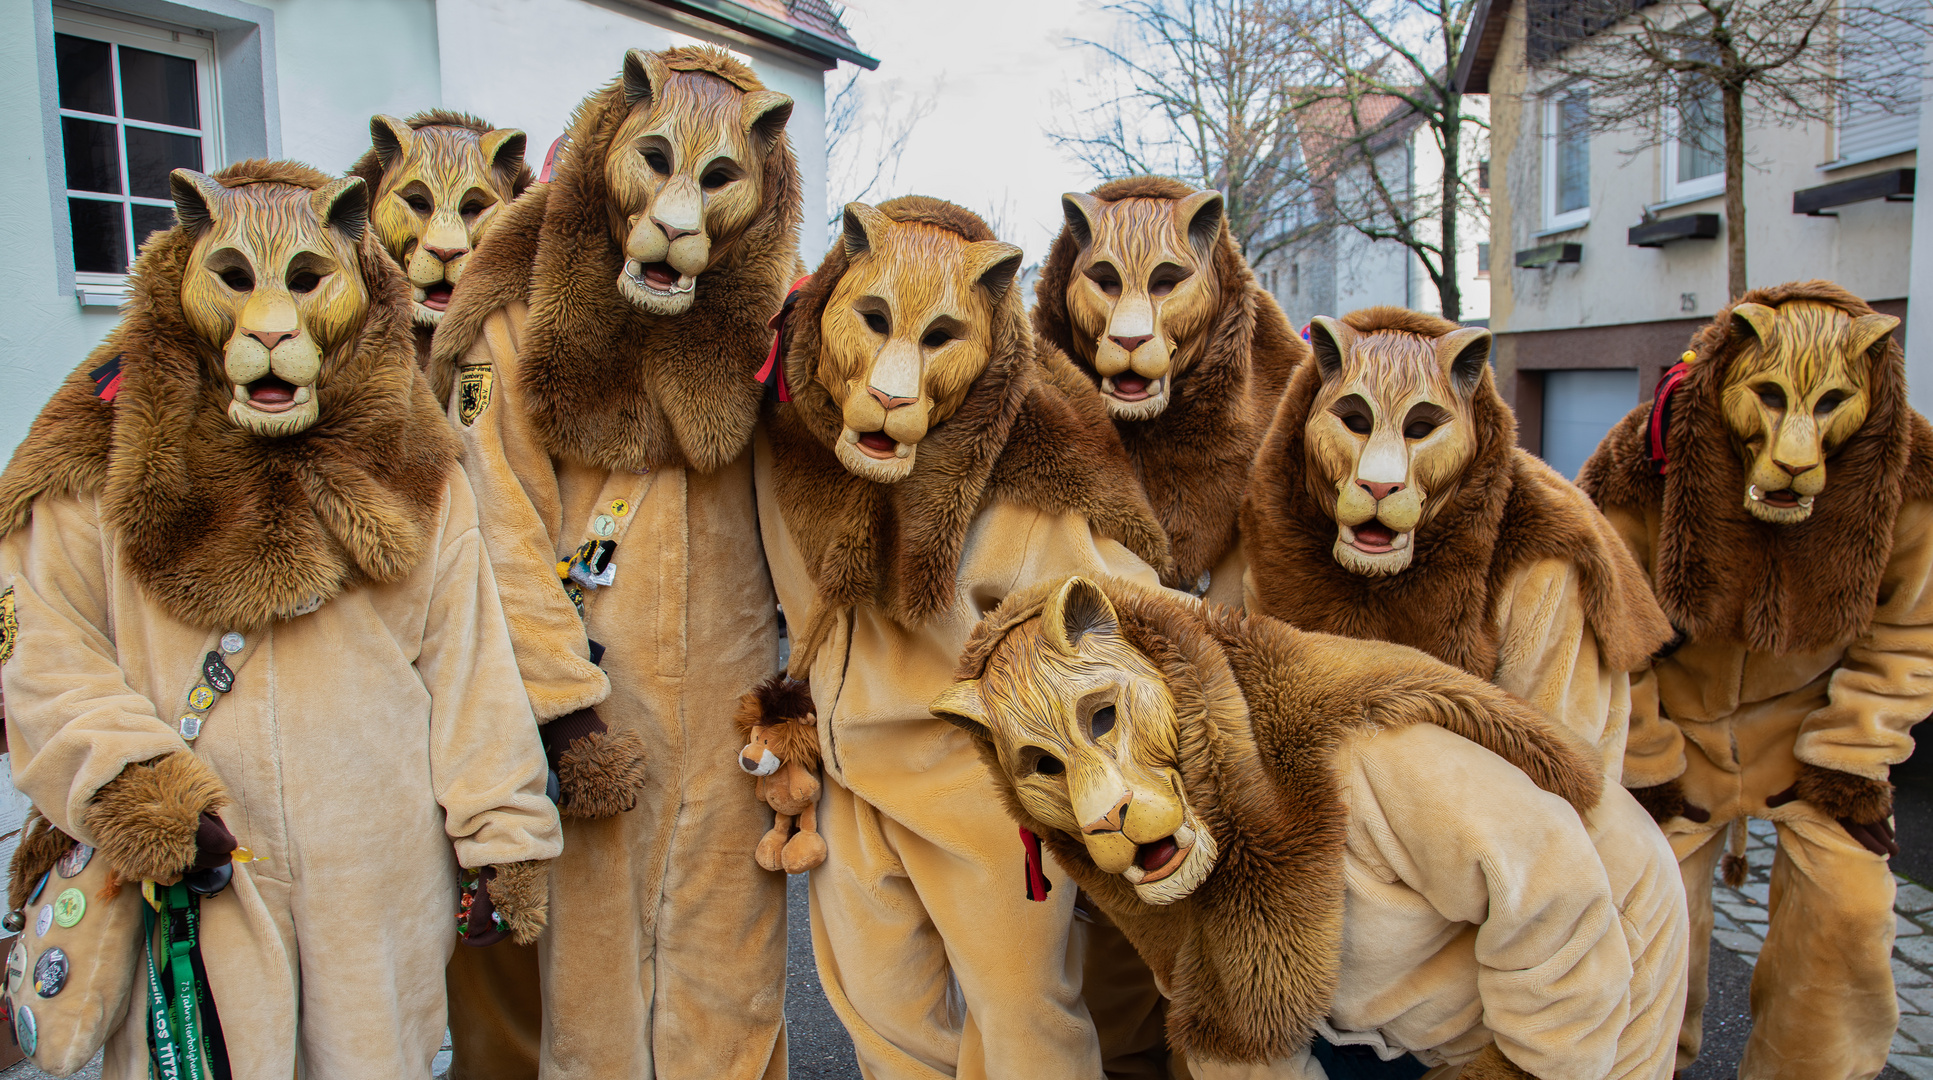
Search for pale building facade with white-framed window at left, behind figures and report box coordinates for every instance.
[0,0,878,454]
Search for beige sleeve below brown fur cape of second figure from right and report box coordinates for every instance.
[1490,558,1631,781]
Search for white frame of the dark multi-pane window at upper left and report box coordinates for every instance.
[54,8,224,307]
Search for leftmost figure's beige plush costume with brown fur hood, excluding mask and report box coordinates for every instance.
[0,162,559,1080]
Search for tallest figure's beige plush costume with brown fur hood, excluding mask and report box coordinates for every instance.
[433,48,800,1080]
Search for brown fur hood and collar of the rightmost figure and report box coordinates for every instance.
[1577,280,1933,653]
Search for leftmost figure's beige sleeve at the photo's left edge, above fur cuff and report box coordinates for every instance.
[0,497,188,844]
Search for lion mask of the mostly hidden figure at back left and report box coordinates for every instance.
[356,110,530,327]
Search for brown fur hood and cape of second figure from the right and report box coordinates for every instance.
[1241,309,1672,680]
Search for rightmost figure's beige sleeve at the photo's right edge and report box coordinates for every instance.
[1794,502,1933,781]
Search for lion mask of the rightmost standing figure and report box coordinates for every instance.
[1720,299,1900,526]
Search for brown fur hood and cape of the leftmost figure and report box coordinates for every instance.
[0,160,456,628]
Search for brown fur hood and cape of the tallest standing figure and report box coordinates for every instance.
[431,48,800,471]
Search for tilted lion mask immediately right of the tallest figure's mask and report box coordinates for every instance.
[818,203,1021,483]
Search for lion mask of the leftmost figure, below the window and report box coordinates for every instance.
[168,168,369,435]
